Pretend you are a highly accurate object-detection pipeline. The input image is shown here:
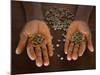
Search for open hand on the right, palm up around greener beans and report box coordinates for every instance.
[64,21,94,61]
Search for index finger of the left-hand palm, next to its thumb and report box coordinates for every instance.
[27,42,36,60]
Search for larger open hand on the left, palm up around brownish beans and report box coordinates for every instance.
[16,20,53,67]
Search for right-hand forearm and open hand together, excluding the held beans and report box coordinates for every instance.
[64,6,94,61]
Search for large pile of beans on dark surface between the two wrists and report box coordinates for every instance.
[45,8,74,31]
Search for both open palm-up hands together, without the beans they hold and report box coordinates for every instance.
[16,20,94,67]
